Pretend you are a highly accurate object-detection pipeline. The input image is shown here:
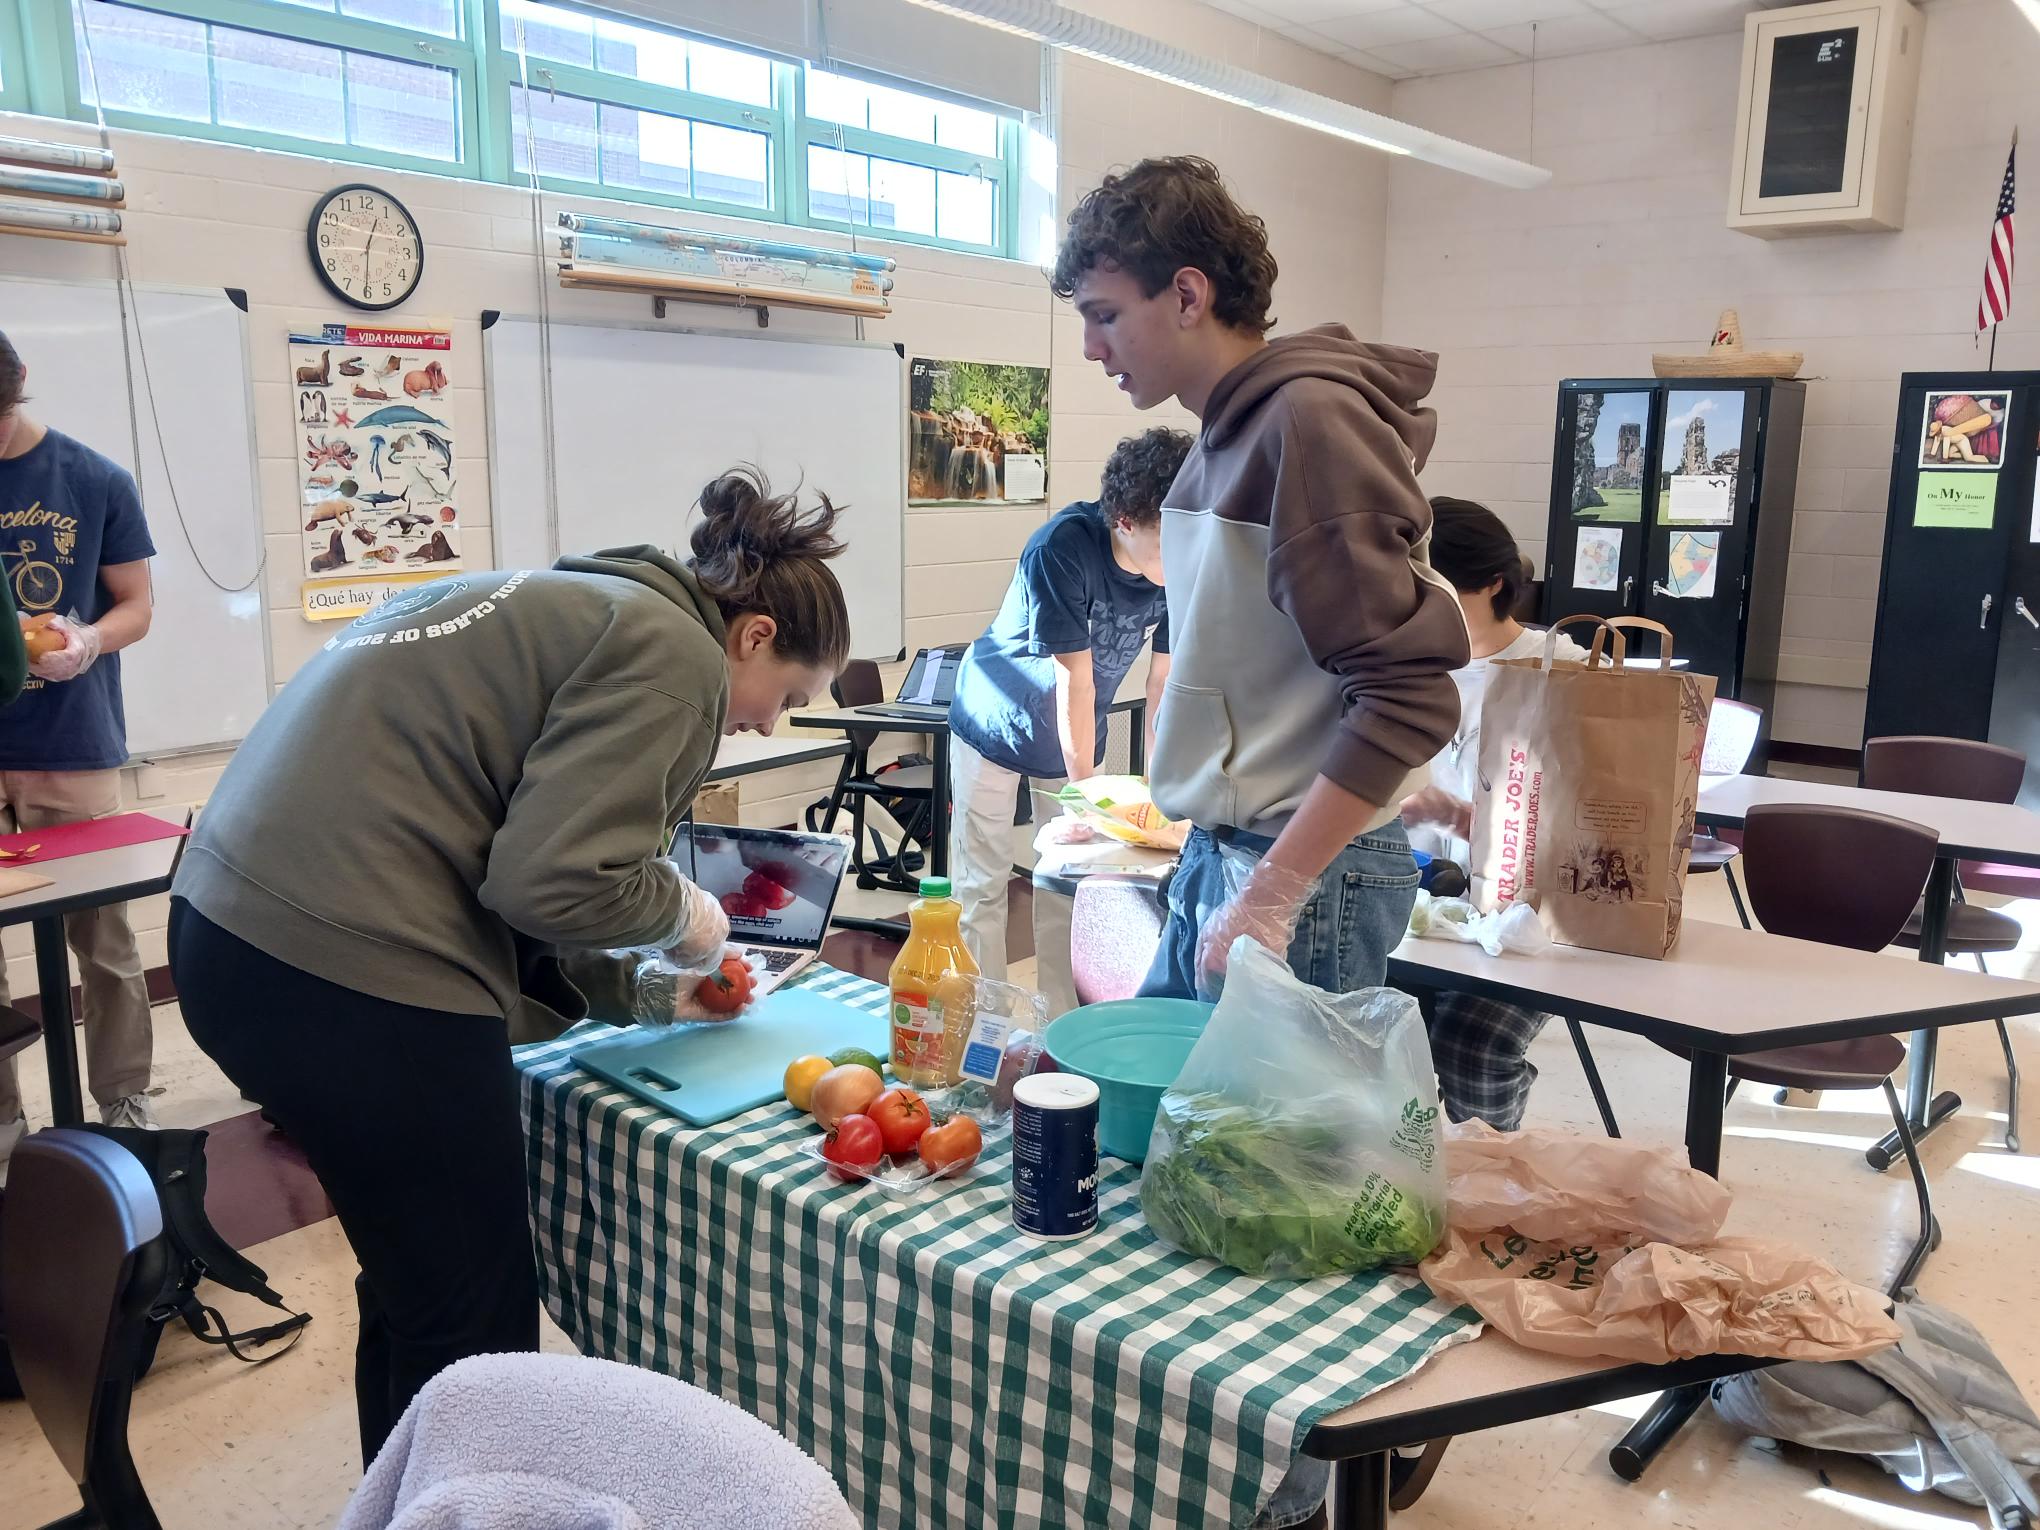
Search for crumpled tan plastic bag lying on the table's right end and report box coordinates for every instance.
[1418,1122,1899,1365]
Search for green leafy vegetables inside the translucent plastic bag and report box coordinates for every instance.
[1140,1093,1444,1279]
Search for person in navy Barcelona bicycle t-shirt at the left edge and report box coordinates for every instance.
[0,335,155,1163]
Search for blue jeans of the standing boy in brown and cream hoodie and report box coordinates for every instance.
[1140,820,1418,1530]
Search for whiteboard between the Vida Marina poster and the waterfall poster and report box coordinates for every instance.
[483,318,906,659]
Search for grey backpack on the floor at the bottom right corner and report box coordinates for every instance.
[1714,1302,2040,1530]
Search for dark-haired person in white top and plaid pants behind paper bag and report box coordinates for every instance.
[1401,498,1587,1132]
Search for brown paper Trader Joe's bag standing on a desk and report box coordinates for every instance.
[1473,616,1714,957]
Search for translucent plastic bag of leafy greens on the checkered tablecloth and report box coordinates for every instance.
[1140,938,1444,1279]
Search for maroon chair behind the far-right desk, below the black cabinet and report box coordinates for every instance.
[1863,734,2040,1153]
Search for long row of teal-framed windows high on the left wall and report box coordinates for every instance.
[0,0,1020,255]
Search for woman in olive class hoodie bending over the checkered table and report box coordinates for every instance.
[169,471,851,1459]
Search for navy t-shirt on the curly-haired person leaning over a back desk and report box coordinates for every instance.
[949,502,1169,777]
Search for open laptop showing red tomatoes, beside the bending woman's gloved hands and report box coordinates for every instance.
[673,822,851,993]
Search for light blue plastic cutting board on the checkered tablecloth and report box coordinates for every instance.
[573,987,891,1126]
